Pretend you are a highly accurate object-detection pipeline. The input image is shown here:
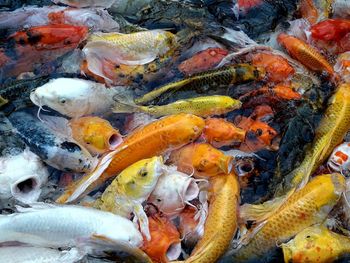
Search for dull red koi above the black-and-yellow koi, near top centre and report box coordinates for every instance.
[178,48,228,75]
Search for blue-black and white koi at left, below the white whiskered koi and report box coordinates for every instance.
[9,111,95,172]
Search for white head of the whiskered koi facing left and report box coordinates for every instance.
[30,78,92,117]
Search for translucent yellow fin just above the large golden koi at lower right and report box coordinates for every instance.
[239,189,295,225]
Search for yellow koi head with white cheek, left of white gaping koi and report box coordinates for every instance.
[117,156,164,199]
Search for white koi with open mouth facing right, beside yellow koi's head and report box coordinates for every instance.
[148,167,199,216]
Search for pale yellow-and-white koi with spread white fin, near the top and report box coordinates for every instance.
[83,30,176,81]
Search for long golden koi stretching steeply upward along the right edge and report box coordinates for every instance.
[277,83,350,195]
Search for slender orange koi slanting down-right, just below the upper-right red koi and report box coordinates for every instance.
[277,33,335,77]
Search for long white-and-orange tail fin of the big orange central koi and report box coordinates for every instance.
[62,145,127,203]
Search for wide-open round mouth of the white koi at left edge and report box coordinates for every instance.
[11,175,41,204]
